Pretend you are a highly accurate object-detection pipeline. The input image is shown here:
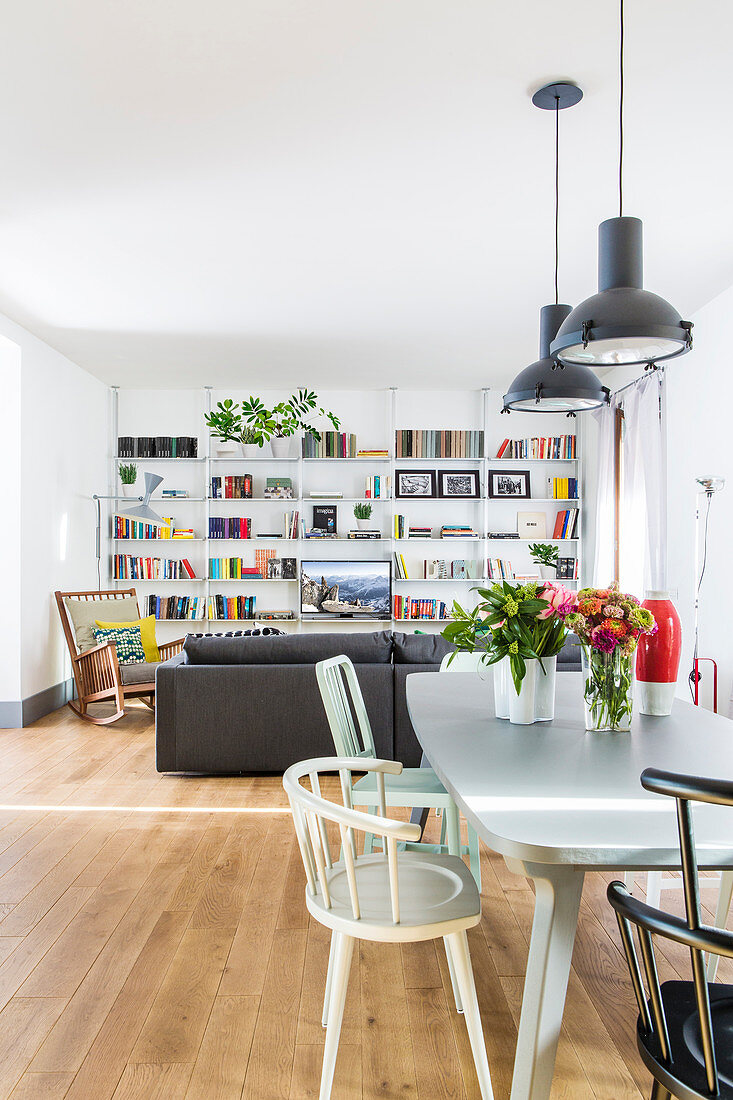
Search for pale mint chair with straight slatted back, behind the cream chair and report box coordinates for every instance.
[316,657,481,890]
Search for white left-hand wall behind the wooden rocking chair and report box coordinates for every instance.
[0,316,108,700]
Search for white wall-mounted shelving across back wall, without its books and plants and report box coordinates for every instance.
[108,389,583,630]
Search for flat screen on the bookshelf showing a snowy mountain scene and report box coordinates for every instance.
[300,561,392,619]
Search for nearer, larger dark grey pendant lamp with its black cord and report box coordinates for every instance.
[550,0,692,366]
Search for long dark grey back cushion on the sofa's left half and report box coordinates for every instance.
[184,630,392,664]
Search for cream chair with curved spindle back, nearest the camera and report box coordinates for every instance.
[283,756,493,1100]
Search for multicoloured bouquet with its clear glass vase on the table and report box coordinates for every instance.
[565,584,657,729]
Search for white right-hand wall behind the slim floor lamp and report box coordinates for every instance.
[667,287,733,714]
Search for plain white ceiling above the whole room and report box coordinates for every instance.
[0,0,733,388]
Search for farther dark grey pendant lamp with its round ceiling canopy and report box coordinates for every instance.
[504,83,609,413]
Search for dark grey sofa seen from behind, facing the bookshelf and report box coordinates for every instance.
[155,630,580,776]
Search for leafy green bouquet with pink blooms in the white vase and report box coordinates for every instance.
[442,581,576,695]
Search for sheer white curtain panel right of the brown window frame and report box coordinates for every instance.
[617,371,667,596]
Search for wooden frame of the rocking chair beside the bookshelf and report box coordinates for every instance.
[54,589,185,726]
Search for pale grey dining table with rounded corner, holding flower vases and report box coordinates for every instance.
[407,670,733,1100]
